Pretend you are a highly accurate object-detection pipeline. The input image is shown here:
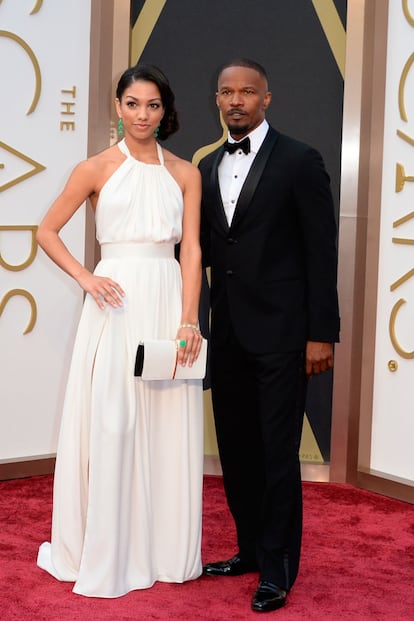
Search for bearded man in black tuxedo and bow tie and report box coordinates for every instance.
[200,59,339,612]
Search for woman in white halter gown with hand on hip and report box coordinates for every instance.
[38,65,203,597]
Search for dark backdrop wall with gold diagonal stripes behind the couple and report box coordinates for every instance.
[131,0,346,463]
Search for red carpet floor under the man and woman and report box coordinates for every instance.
[0,476,414,621]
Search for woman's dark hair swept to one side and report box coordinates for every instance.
[116,65,179,140]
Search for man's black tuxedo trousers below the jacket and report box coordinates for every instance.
[211,326,306,590]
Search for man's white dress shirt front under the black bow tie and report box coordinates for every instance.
[218,119,269,226]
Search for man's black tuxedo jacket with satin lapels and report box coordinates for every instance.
[199,127,339,354]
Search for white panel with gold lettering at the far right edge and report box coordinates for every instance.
[369,2,414,484]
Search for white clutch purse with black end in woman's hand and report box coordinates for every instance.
[134,339,207,380]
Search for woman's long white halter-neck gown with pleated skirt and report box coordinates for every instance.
[38,141,203,597]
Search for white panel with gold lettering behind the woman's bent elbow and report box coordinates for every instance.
[0,0,90,462]
